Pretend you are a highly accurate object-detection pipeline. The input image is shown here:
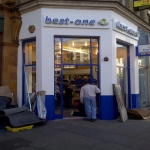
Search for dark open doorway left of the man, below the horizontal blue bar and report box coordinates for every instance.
[63,65,90,118]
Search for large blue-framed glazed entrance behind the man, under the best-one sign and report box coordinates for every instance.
[54,37,99,119]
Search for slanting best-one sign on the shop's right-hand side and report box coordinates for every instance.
[116,21,140,37]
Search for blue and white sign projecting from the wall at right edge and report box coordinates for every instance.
[136,44,150,56]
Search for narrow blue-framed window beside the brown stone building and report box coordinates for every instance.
[22,39,36,105]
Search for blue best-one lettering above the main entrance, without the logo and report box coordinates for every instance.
[45,16,95,26]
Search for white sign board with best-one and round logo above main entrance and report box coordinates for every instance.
[44,16,110,28]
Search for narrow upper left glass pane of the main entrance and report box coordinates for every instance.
[55,38,61,64]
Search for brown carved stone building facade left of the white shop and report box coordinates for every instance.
[0,0,22,102]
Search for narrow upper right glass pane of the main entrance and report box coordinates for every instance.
[92,39,98,64]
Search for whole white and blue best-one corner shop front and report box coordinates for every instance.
[18,8,139,120]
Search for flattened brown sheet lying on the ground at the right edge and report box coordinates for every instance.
[127,109,150,119]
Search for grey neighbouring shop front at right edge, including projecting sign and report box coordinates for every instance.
[136,44,150,109]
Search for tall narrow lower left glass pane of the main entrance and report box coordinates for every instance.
[55,65,62,114]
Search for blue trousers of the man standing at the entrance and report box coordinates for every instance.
[83,97,96,119]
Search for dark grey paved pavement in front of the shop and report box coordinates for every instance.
[0,119,150,150]
